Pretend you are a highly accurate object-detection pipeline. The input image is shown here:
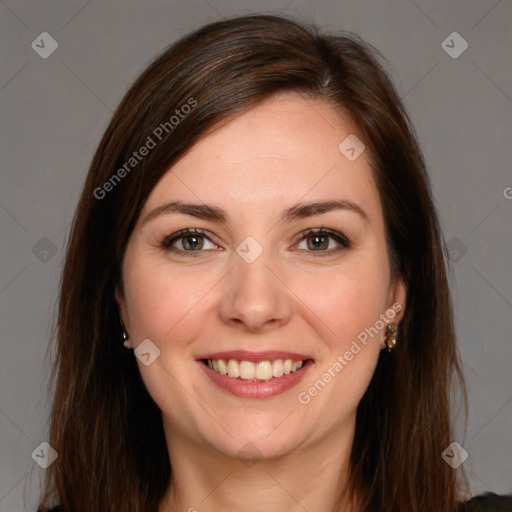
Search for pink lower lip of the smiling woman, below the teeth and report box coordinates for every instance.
[198,359,313,398]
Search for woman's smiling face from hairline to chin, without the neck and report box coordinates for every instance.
[116,93,405,457]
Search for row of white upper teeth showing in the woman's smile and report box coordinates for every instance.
[206,359,304,380]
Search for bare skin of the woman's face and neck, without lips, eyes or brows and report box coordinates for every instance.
[116,93,406,512]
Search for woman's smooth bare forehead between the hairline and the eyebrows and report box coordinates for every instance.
[142,93,380,226]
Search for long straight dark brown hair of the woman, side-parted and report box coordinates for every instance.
[37,15,466,512]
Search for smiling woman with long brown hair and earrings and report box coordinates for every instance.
[37,16,510,512]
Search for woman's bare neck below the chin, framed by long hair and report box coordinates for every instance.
[159,419,355,512]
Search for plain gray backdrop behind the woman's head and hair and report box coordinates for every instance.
[0,0,512,512]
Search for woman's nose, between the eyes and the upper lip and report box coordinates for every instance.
[220,247,293,332]
